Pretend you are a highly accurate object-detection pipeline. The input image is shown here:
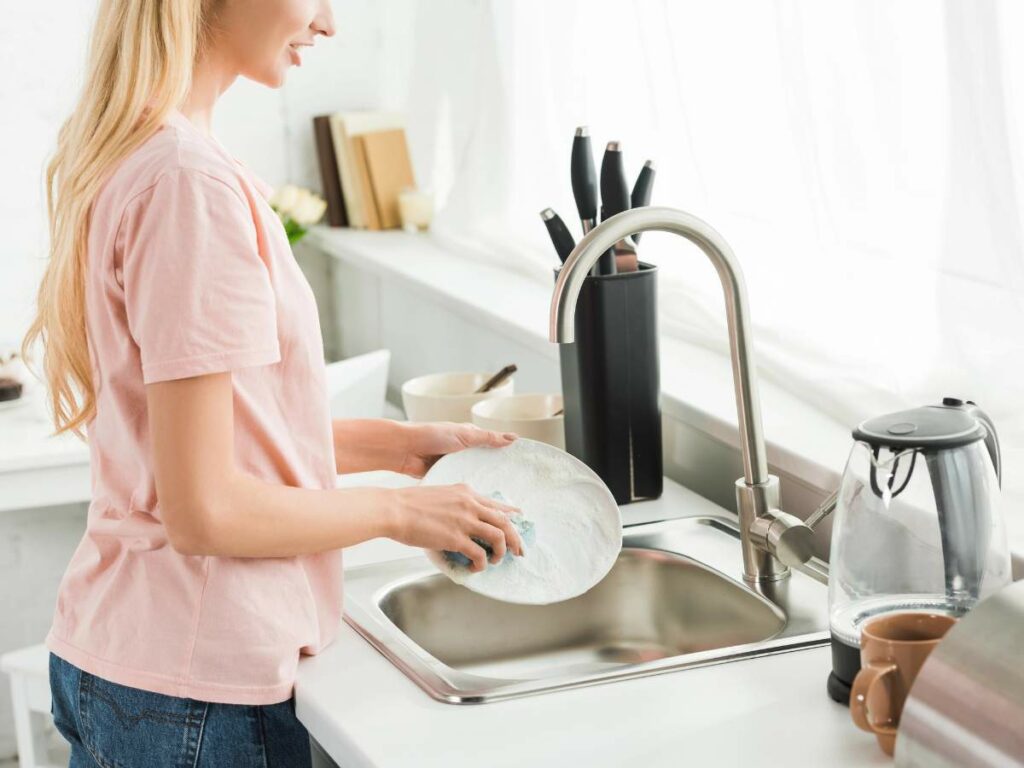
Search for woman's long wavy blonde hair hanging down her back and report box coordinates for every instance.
[22,0,210,438]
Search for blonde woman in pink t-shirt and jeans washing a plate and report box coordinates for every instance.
[25,0,522,768]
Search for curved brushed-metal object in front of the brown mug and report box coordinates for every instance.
[896,582,1024,768]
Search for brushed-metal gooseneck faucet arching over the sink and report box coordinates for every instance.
[550,207,830,582]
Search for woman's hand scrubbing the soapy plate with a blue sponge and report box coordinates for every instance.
[388,484,522,572]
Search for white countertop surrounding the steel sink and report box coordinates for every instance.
[295,473,891,768]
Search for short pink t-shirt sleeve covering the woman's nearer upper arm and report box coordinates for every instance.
[119,169,281,384]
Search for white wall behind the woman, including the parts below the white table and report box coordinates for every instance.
[0,0,381,759]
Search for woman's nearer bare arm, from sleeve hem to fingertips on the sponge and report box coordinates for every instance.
[146,373,522,570]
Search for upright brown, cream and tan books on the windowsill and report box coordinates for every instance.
[313,112,416,229]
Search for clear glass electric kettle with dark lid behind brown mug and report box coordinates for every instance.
[828,397,1011,703]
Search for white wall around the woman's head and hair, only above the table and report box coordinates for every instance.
[0,0,382,352]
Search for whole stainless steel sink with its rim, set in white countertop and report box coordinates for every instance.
[345,517,828,703]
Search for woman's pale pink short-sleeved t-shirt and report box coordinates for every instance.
[46,112,342,705]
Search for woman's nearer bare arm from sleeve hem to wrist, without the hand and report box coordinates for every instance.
[146,374,397,557]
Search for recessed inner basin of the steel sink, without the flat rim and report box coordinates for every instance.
[381,548,785,678]
